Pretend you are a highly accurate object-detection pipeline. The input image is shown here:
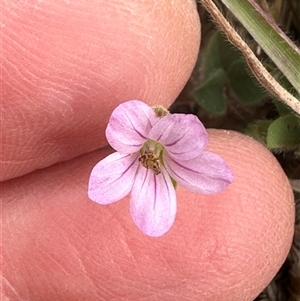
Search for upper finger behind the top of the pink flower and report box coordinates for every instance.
[1,0,200,180]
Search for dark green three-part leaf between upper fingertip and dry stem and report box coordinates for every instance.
[192,31,268,115]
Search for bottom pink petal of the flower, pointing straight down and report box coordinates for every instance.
[130,166,177,237]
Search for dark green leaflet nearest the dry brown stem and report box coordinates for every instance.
[227,59,267,105]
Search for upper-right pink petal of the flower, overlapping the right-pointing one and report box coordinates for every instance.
[149,114,208,160]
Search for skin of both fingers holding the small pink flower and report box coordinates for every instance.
[1,0,294,301]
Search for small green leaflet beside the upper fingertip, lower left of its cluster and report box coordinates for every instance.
[192,69,226,115]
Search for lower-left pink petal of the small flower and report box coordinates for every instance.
[88,152,139,205]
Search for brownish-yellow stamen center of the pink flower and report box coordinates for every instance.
[139,139,164,175]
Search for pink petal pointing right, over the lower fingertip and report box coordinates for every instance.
[164,151,233,194]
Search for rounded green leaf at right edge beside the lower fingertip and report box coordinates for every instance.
[267,114,300,150]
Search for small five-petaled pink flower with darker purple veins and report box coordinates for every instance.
[88,100,233,236]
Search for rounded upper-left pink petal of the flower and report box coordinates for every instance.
[106,100,159,154]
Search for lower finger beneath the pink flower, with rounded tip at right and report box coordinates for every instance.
[2,130,294,301]
